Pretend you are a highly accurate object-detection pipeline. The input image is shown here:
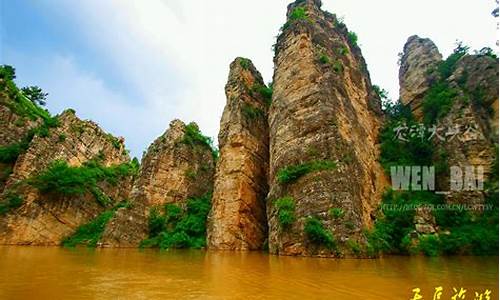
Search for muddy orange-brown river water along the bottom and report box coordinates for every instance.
[0,247,498,300]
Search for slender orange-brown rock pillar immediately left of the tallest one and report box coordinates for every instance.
[208,58,270,250]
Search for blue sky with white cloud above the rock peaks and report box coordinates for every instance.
[0,0,497,157]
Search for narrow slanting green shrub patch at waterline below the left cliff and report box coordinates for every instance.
[62,208,116,248]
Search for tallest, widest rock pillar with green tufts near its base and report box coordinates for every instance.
[267,0,385,256]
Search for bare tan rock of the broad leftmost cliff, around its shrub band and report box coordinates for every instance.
[0,111,131,245]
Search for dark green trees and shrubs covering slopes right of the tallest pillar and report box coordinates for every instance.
[372,44,498,256]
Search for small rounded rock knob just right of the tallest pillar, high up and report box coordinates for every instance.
[399,35,443,119]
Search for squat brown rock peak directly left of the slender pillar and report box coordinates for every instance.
[101,120,215,247]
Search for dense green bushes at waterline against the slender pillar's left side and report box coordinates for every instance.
[141,193,211,249]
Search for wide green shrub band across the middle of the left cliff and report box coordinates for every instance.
[27,159,139,205]
